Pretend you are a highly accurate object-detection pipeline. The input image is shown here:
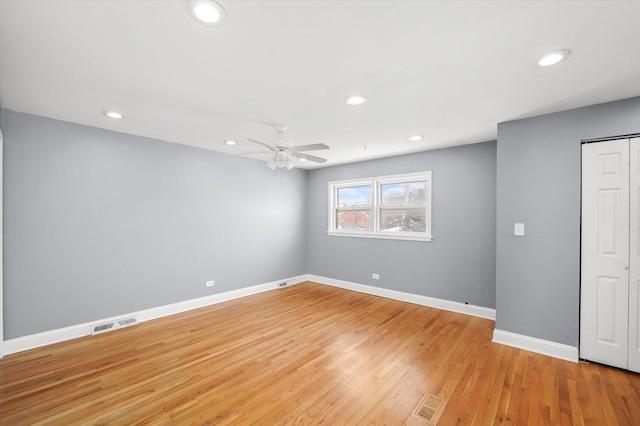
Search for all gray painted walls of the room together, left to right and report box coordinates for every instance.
[12,98,640,346]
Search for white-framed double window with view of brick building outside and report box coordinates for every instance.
[328,172,431,241]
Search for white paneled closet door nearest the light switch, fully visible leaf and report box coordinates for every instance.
[580,139,629,368]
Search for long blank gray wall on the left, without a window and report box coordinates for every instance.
[0,110,307,339]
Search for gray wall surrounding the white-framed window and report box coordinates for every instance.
[308,142,496,308]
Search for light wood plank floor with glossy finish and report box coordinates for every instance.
[0,283,640,426]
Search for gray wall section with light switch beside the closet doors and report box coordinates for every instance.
[496,98,640,346]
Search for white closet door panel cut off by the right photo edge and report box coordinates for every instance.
[628,138,640,373]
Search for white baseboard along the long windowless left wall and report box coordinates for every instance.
[4,276,305,355]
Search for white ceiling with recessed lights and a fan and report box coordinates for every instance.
[0,0,640,168]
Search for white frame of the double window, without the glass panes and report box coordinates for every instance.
[327,171,433,241]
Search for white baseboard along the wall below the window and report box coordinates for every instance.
[303,274,496,321]
